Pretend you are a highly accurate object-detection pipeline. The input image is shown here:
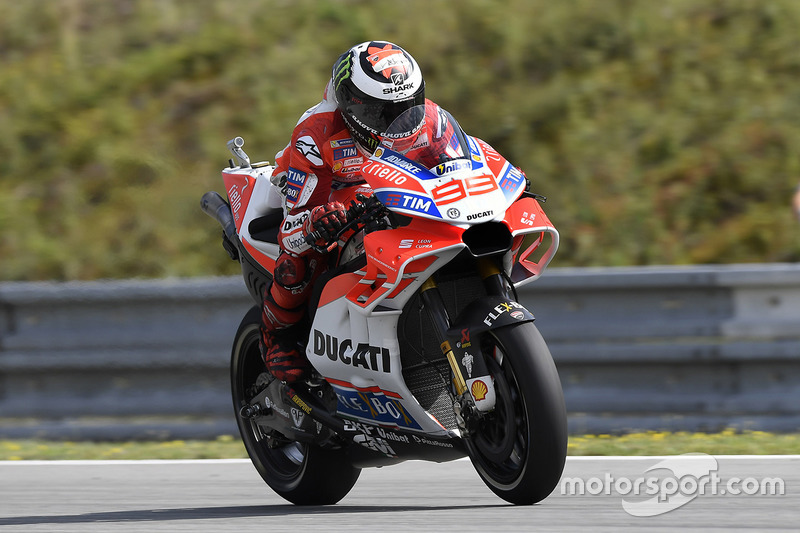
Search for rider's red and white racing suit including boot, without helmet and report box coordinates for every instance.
[262,83,460,381]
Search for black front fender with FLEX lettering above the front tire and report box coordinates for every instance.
[447,296,536,339]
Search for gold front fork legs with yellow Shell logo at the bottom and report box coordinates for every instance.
[420,258,506,432]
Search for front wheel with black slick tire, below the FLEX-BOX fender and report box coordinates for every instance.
[465,322,567,505]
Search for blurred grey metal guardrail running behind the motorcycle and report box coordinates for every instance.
[0,264,800,439]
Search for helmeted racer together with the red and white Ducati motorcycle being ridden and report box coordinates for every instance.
[200,42,567,505]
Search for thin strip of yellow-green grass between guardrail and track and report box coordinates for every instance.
[0,429,800,461]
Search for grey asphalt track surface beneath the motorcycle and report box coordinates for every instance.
[0,456,800,533]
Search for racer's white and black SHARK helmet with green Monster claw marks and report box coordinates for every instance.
[331,41,425,153]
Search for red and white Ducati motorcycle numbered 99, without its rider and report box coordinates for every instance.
[202,104,567,505]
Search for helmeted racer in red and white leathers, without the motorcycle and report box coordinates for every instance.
[260,41,460,382]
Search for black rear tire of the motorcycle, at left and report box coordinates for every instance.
[231,306,361,505]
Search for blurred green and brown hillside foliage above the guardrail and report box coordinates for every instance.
[0,0,800,280]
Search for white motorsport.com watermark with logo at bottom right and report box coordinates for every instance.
[561,453,786,516]
